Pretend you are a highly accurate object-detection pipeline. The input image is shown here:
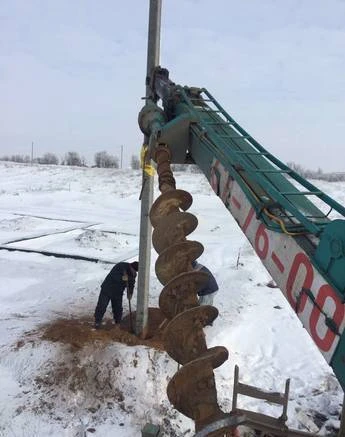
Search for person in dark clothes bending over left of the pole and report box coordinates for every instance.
[95,261,138,329]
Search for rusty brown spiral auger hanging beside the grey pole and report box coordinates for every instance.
[150,144,232,436]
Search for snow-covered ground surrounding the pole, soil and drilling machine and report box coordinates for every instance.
[0,163,345,437]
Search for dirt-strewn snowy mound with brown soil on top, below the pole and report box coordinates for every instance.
[10,308,176,435]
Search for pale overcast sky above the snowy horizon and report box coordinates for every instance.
[0,0,345,171]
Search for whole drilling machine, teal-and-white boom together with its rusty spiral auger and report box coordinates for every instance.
[139,67,345,436]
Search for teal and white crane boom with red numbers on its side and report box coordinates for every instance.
[139,67,345,389]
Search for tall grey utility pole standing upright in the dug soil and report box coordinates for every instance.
[136,0,162,338]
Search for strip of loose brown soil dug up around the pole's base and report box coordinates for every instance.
[33,308,164,350]
